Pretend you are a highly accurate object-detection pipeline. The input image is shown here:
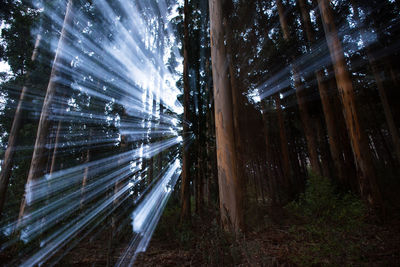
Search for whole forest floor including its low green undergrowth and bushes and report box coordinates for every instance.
[0,178,400,267]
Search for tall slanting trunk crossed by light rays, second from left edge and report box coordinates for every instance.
[19,0,73,224]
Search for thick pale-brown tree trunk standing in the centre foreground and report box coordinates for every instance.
[209,0,243,231]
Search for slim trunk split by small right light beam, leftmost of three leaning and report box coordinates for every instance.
[276,0,322,175]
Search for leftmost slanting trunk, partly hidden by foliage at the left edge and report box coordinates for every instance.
[0,35,41,219]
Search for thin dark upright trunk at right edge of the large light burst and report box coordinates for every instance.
[181,0,190,222]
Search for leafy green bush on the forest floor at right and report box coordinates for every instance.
[286,174,366,266]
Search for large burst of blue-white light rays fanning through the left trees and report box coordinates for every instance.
[0,0,184,266]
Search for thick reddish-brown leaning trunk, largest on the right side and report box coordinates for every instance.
[318,0,382,207]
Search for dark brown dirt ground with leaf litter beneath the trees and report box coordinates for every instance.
[0,207,400,266]
